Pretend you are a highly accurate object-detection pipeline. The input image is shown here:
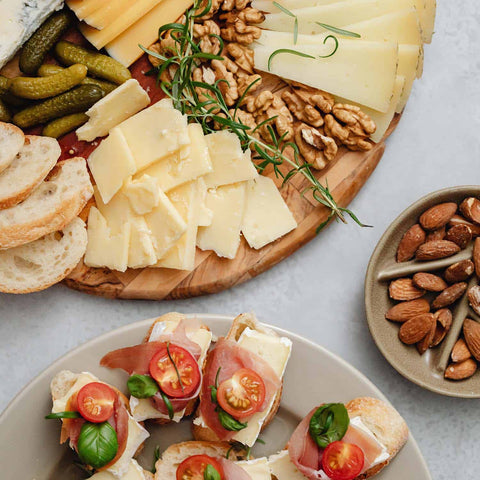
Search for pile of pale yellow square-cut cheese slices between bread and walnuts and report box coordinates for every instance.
[84,80,297,271]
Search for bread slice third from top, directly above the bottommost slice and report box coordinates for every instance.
[0,157,93,250]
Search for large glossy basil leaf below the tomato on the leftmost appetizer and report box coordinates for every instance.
[77,422,118,469]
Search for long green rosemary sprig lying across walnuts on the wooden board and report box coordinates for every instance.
[142,0,364,232]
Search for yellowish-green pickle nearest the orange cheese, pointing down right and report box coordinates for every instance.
[55,41,132,84]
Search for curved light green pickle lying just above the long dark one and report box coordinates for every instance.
[10,64,87,100]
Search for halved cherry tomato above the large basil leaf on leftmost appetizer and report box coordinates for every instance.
[76,382,117,423]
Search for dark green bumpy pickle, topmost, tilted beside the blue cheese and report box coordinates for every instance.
[20,10,72,75]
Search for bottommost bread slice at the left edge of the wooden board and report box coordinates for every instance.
[0,218,87,293]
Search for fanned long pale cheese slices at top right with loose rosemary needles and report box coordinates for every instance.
[252,0,436,141]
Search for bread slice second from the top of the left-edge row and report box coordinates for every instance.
[0,135,62,209]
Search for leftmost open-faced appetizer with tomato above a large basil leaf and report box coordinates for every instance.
[47,370,149,480]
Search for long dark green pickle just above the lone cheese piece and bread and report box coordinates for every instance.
[13,85,104,128]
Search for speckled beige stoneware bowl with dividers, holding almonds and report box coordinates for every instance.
[365,185,480,398]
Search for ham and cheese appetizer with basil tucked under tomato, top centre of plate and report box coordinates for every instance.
[193,314,292,446]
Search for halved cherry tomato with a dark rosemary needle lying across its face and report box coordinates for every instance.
[150,345,200,398]
